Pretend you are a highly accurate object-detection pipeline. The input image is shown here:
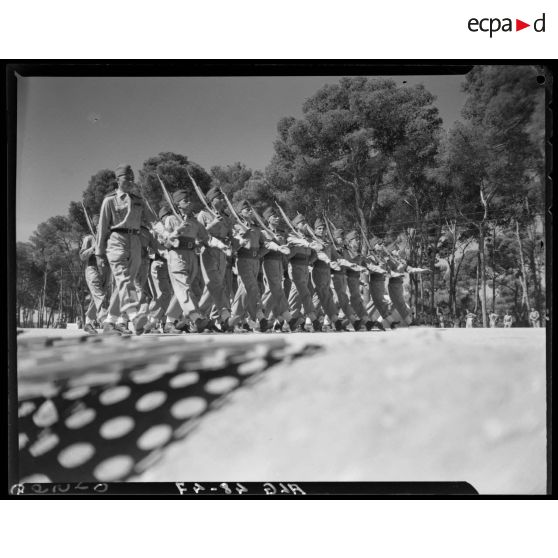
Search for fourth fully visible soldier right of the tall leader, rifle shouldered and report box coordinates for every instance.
[262,207,292,331]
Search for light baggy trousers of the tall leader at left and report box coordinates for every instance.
[106,232,141,319]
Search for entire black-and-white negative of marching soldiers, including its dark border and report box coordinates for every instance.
[8,62,552,498]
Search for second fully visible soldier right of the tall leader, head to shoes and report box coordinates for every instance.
[197,188,234,331]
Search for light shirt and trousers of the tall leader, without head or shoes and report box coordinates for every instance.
[95,190,148,318]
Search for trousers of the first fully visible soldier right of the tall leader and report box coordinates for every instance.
[167,250,201,320]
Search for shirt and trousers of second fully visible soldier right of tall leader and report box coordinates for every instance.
[197,210,233,317]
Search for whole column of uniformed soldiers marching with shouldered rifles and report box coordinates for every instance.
[80,165,427,335]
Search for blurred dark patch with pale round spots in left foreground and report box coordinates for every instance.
[19,341,318,483]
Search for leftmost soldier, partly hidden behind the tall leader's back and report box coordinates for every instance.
[79,215,110,335]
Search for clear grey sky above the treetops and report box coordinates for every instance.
[16,76,465,241]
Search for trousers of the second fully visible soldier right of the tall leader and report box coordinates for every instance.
[200,247,230,317]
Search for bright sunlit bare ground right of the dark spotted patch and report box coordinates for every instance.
[126,328,546,494]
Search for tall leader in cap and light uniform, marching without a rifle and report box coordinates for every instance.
[95,165,148,335]
